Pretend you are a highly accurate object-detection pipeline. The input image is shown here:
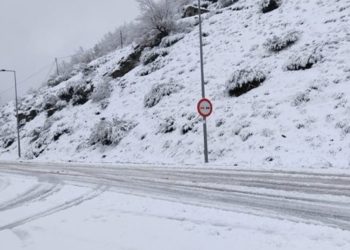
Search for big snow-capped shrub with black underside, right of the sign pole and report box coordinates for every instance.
[226,69,266,97]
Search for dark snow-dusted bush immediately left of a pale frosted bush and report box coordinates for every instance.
[58,81,94,106]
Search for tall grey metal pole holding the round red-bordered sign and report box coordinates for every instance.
[198,0,209,163]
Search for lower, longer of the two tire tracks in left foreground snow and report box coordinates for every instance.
[0,186,108,232]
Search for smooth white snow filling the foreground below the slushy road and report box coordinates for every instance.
[0,174,350,250]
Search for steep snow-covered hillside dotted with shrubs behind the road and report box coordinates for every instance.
[0,0,350,169]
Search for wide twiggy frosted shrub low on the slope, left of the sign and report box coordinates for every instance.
[89,118,137,146]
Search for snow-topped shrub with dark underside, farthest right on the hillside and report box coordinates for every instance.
[285,50,322,71]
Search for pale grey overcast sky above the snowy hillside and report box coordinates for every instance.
[0,0,138,103]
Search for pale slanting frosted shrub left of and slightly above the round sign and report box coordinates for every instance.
[144,83,184,108]
